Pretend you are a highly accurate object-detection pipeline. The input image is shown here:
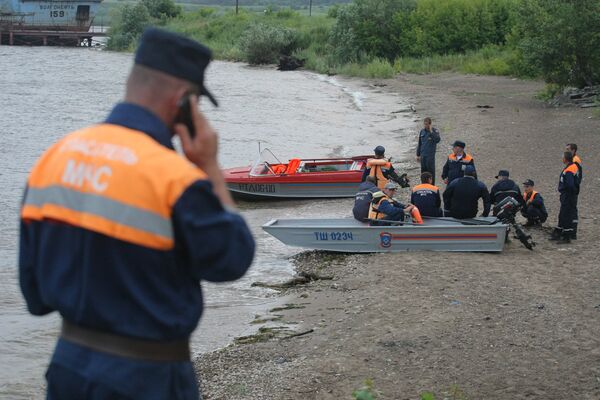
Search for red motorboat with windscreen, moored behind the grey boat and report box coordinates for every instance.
[223,149,372,200]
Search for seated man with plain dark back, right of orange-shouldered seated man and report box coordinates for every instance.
[444,165,491,219]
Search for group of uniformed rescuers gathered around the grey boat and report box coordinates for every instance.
[352,118,582,243]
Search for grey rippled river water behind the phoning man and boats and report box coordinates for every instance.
[0,46,416,399]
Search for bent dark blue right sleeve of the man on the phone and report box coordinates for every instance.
[172,181,255,282]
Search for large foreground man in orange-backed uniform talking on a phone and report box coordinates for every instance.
[19,29,254,400]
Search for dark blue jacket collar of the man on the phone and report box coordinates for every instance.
[105,103,174,150]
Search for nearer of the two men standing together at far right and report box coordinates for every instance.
[550,151,579,243]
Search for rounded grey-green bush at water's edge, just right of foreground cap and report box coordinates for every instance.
[240,24,300,64]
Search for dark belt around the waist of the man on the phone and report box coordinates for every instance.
[60,320,190,362]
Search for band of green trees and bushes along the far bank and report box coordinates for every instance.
[109,0,600,87]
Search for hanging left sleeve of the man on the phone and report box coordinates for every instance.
[19,221,53,315]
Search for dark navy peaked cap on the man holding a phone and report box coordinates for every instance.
[135,28,219,106]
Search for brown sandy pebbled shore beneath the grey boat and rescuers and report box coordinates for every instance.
[196,74,600,400]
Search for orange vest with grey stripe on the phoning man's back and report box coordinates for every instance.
[21,124,206,250]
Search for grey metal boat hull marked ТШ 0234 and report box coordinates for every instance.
[263,217,507,253]
